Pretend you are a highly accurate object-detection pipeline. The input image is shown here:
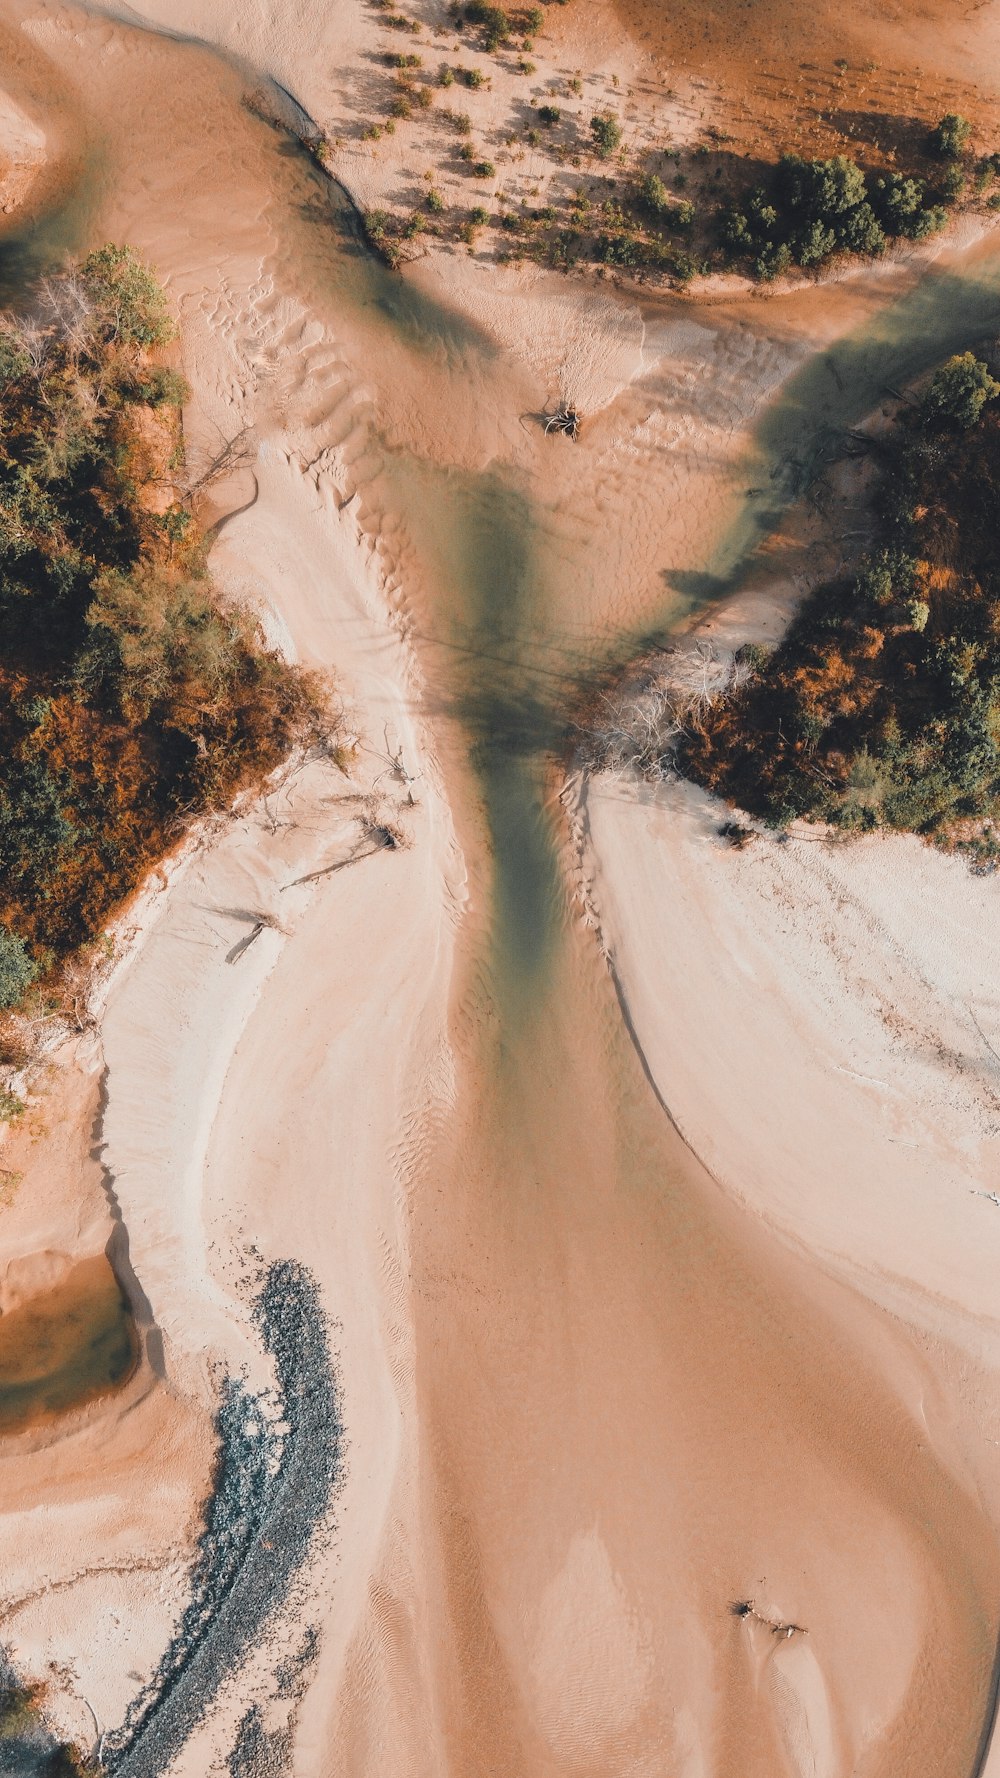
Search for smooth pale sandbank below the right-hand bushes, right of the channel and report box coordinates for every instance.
[585,779,1000,1337]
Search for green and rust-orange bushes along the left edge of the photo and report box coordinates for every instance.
[0,245,322,1006]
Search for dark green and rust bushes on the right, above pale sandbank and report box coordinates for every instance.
[678,352,1000,842]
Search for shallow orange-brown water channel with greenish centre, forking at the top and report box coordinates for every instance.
[0,10,1000,1778]
